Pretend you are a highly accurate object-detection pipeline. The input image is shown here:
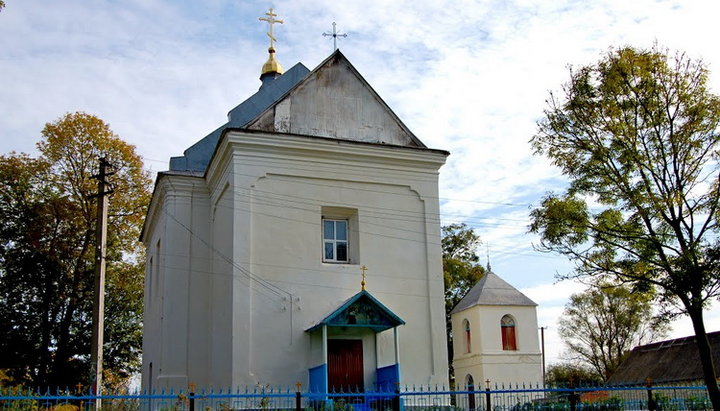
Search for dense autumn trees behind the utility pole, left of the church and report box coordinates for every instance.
[0,113,150,386]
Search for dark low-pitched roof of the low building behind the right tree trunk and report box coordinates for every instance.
[608,331,720,384]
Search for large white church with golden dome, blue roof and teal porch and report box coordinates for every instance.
[141,10,449,392]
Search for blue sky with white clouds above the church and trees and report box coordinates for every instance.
[0,0,720,362]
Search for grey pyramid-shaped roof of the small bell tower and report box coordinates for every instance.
[450,271,537,314]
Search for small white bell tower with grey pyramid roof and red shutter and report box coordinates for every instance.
[450,269,543,390]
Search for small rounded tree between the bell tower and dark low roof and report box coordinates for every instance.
[559,282,667,381]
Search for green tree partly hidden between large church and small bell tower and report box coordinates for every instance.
[442,223,485,381]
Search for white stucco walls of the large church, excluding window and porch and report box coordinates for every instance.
[143,132,447,389]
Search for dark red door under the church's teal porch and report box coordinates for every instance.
[328,340,365,392]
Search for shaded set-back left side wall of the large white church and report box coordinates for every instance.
[142,176,210,390]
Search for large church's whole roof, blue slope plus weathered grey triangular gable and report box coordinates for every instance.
[170,50,427,172]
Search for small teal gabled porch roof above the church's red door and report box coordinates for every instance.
[305,290,405,332]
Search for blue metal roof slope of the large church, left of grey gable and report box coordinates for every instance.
[170,63,310,172]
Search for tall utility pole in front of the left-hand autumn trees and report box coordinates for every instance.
[90,157,115,410]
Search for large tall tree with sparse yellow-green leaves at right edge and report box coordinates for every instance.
[530,47,720,409]
